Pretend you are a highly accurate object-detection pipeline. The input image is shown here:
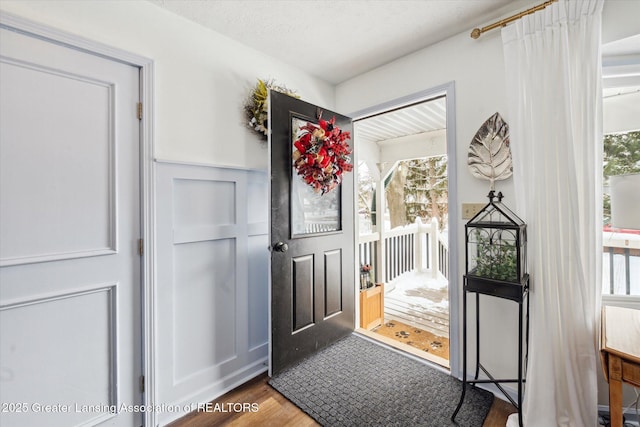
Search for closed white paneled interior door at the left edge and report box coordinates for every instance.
[0,29,142,426]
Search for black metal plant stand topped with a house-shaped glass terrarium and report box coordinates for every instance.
[451,191,529,427]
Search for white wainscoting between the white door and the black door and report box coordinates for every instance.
[156,162,270,425]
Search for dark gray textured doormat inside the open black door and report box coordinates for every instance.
[269,335,493,427]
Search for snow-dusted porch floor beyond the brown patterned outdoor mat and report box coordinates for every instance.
[384,271,449,339]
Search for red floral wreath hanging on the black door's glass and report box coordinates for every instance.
[293,117,353,194]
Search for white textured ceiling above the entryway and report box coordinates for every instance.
[149,0,512,84]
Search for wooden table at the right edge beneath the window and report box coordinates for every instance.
[600,306,640,427]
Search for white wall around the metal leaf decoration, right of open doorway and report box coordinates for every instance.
[336,0,640,404]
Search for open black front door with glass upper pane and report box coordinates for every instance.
[269,92,355,375]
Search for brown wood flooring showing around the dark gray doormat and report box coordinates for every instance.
[169,374,516,427]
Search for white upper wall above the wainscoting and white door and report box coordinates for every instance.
[0,0,334,169]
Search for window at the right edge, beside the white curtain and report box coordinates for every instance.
[602,54,640,298]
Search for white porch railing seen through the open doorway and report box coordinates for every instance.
[358,218,449,282]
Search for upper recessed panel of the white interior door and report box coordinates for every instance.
[0,59,116,265]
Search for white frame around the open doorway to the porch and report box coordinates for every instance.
[347,81,462,378]
